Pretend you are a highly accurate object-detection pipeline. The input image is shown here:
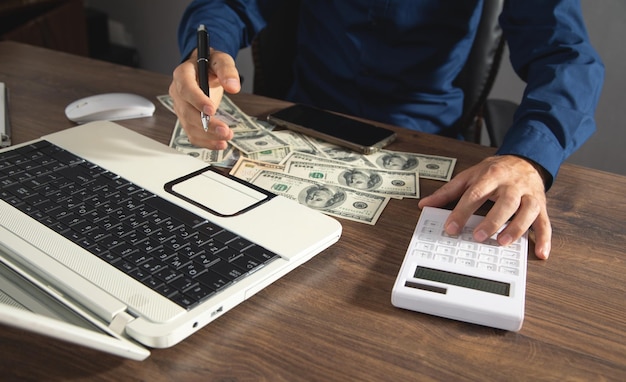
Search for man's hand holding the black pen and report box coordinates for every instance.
[169,50,241,150]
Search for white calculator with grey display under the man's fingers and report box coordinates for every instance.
[391,207,528,331]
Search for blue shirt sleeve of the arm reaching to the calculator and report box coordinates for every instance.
[498,0,604,189]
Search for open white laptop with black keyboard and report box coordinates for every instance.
[0,121,341,360]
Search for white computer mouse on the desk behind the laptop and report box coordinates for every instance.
[65,93,155,123]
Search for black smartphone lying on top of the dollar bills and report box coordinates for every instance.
[267,104,396,154]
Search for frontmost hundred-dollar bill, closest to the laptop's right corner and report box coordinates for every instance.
[250,170,389,225]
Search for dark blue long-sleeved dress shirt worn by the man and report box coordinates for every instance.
[178,0,604,187]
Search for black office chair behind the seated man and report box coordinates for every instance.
[251,0,517,147]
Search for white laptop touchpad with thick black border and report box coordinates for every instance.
[165,167,274,216]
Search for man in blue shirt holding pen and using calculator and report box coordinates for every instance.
[170,0,604,259]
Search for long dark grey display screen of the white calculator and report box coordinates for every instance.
[414,267,511,296]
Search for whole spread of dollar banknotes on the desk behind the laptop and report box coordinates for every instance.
[158,95,456,224]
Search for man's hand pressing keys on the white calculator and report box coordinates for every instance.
[419,155,552,259]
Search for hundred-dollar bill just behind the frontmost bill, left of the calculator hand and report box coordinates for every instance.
[285,161,419,198]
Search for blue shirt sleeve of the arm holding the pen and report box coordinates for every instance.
[178,0,266,60]
